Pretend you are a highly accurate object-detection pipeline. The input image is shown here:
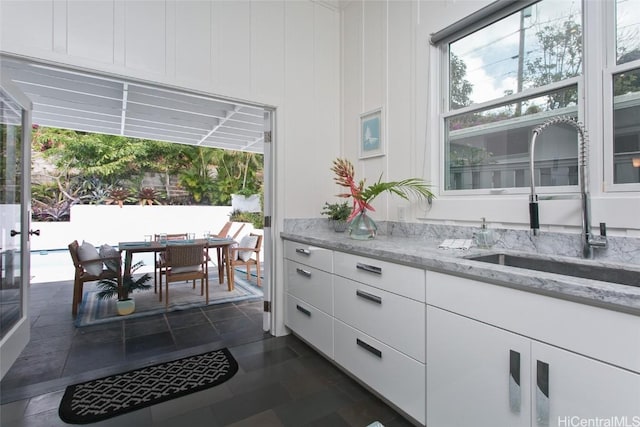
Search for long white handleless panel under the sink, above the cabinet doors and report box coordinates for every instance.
[427,271,640,372]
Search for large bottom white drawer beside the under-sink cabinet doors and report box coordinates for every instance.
[334,320,425,425]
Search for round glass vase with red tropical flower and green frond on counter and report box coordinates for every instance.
[331,158,433,240]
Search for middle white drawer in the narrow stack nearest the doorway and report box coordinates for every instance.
[284,259,333,315]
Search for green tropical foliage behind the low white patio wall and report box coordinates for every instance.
[32,125,263,221]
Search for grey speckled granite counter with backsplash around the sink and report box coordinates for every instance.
[280,220,640,316]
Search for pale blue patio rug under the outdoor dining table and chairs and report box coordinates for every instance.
[75,269,264,327]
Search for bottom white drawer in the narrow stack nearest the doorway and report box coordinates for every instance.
[284,295,333,359]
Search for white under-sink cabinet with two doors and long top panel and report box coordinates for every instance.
[427,278,640,426]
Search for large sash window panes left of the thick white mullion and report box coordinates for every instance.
[442,0,584,191]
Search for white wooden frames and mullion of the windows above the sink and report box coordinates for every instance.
[438,0,640,197]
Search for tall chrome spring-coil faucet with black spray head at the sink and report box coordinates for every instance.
[529,116,607,258]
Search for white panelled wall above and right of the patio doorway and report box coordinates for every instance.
[0,0,340,224]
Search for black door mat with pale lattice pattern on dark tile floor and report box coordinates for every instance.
[58,348,238,424]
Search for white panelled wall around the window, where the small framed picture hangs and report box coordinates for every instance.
[341,0,640,236]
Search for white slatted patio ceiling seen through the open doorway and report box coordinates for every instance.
[0,57,264,153]
